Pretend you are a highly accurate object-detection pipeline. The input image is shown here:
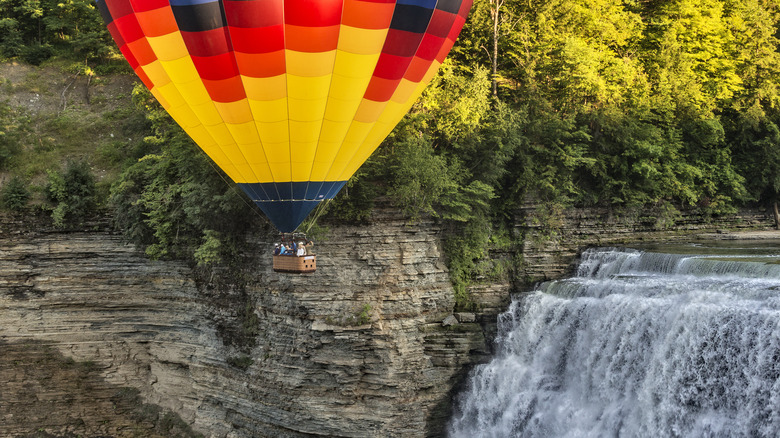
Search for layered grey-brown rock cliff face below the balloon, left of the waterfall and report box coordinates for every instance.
[0,211,487,437]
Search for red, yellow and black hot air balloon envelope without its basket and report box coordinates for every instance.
[97,0,472,232]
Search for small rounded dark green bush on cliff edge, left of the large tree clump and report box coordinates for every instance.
[46,161,97,227]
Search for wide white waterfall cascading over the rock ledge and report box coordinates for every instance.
[449,245,780,438]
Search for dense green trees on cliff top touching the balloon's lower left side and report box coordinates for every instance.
[110,88,257,265]
